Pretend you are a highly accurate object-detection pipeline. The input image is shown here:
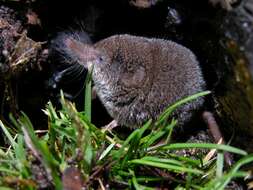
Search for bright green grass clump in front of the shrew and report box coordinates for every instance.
[0,85,253,190]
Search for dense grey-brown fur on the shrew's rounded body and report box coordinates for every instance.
[54,35,205,126]
